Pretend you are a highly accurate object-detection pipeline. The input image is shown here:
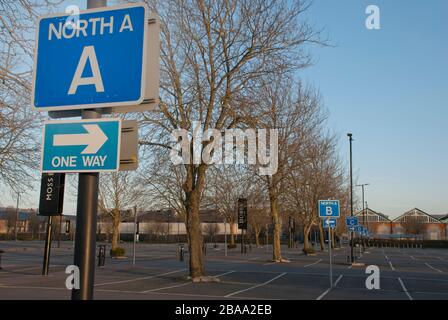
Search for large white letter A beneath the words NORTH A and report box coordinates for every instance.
[68,46,104,94]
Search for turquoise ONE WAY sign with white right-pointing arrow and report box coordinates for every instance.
[41,118,121,173]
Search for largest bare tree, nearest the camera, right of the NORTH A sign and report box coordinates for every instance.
[141,0,317,279]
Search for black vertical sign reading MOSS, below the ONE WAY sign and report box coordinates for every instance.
[39,173,65,216]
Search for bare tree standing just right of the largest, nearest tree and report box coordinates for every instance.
[258,77,326,262]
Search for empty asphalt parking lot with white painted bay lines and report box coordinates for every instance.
[0,241,448,300]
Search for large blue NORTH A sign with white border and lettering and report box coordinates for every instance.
[32,4,148,111]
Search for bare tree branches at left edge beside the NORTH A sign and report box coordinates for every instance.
[0,0,53,191]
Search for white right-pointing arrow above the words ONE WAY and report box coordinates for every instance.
[53,124,108,154]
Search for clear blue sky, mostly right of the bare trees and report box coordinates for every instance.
[2,0,448,217]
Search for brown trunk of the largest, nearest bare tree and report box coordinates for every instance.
[185,189,205,279]
